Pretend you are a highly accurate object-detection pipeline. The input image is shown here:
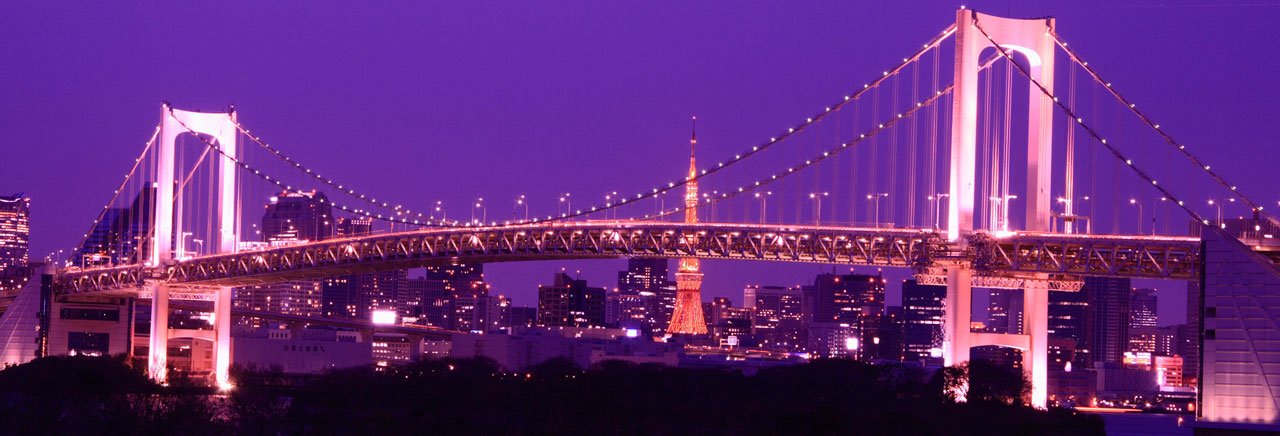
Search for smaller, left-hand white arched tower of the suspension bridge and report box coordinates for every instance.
[145,102,239,389]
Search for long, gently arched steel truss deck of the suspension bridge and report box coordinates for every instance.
[55,220,1201,294]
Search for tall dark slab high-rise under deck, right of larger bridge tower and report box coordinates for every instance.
[1080,277,1133,363]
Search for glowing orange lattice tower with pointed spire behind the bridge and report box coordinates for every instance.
[667,116,707,335]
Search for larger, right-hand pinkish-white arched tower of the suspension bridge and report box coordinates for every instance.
[943,9,1055,408]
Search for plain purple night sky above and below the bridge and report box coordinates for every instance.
[0,0,1280,323]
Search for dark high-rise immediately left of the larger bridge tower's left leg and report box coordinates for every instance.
[902,280,947,366]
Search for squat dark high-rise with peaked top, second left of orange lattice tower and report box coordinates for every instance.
[538,272,604,327]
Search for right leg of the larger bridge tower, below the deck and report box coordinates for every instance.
[1023,280,1048,409]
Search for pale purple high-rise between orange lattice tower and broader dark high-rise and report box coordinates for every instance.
[742,285,808,352]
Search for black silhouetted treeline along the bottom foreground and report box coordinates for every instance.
[0,357,1103,435]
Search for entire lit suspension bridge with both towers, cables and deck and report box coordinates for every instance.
[20,9,1276,416]
